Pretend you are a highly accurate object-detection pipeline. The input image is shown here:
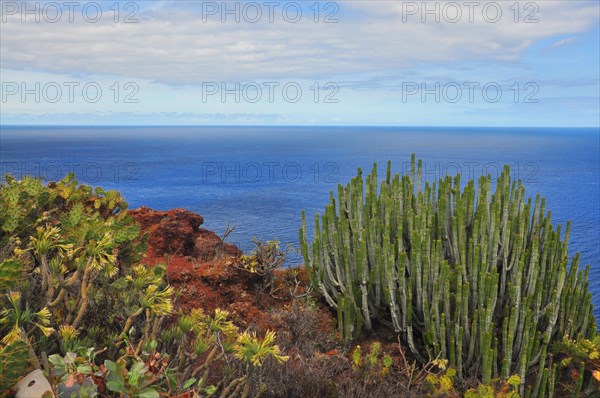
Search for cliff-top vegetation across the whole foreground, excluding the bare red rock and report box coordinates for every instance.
[0,155,600,398]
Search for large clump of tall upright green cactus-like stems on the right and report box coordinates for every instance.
[300,155,596,397]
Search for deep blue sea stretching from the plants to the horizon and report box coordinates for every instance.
[0,127,600,317]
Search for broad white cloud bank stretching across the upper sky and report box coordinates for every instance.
[0,1,599,84]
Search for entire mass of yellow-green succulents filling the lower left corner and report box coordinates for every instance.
[0,175,287,398]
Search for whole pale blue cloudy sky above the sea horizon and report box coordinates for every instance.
[0,0,600,127]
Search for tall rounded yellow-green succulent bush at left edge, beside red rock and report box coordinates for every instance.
[0,175,144,349]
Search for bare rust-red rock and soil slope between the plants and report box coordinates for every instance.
[130,207,318,330]
